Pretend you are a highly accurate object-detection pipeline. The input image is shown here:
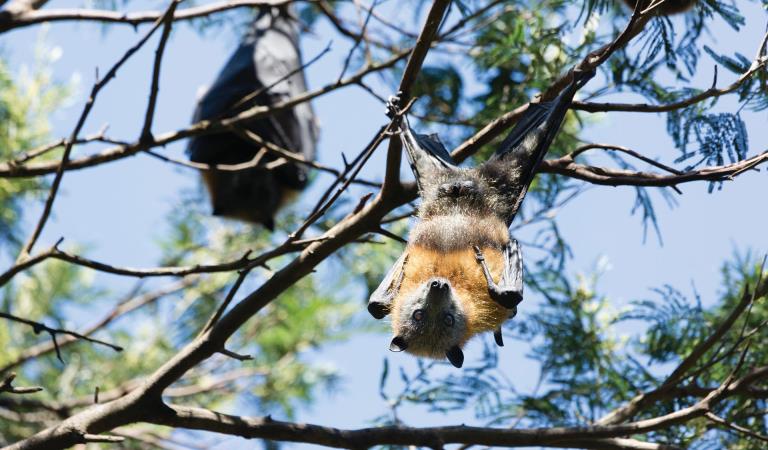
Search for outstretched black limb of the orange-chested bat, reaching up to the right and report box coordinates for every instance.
[483,71,594,224]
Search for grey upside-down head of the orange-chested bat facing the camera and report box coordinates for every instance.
[389,277,467,367]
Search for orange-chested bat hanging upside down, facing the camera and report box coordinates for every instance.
[368,71,594,367]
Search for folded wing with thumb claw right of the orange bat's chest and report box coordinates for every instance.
[475,240,523,309]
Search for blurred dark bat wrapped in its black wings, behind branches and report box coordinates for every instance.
[187,7,318,230]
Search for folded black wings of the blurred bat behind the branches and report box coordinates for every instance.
[187,8,317,189]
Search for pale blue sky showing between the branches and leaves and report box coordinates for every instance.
[0,0,768,448]
